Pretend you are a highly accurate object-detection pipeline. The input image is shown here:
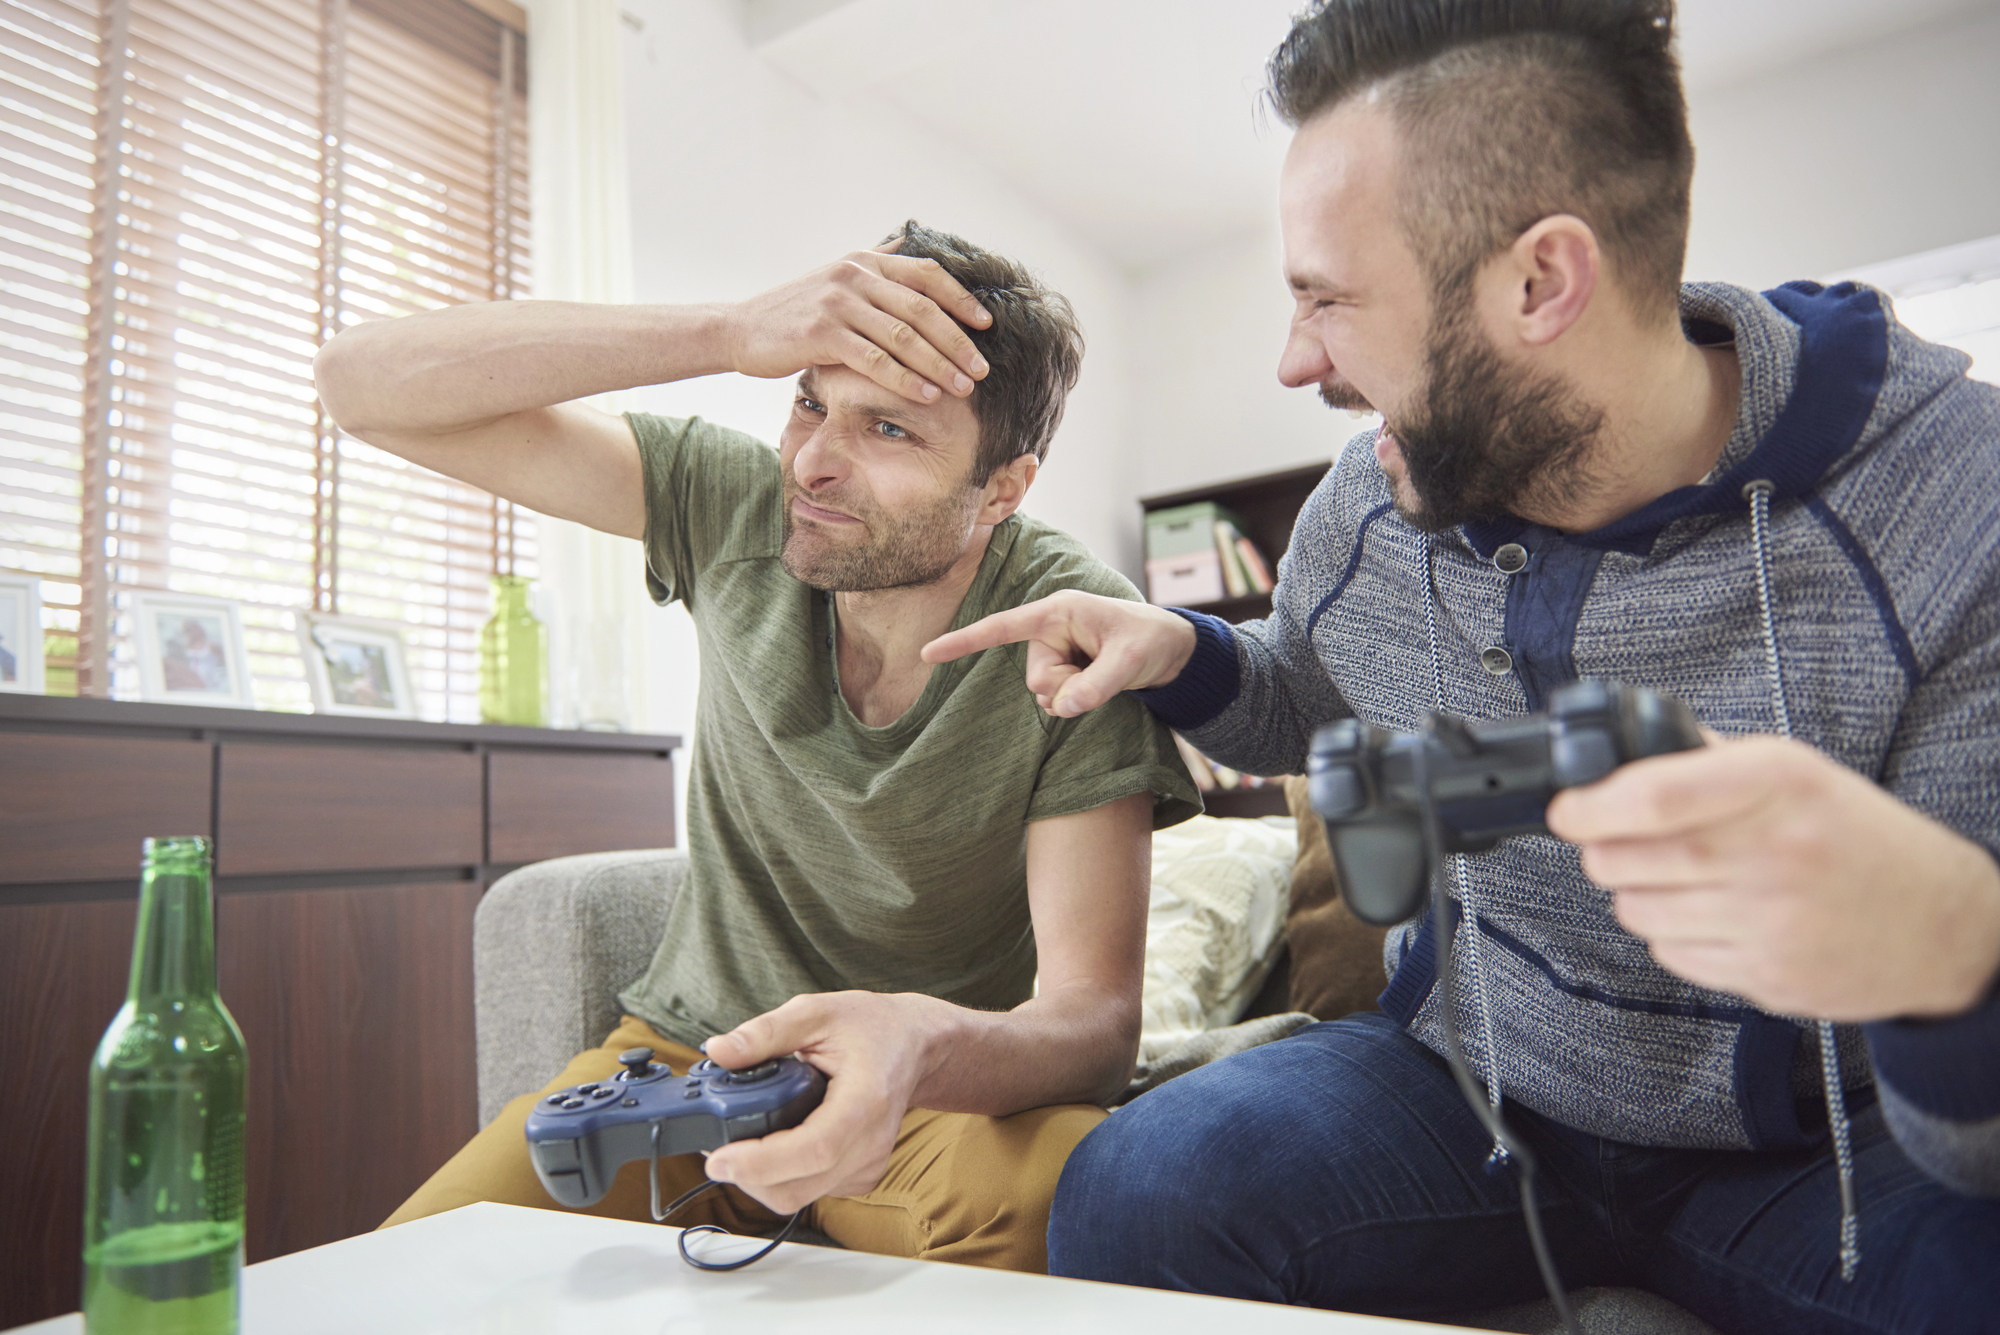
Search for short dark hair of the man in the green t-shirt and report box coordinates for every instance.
[884,218,1084,486]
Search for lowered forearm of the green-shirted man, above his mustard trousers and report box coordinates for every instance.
[908,983,1140,1117]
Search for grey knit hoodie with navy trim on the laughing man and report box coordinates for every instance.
[1140,284,2000,1195]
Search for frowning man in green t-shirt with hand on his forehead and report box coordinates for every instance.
[316,224,1198,1269]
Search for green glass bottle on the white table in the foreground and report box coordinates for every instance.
[84,837,244,1335]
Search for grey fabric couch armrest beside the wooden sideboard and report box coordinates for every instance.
[472,849,688,1125]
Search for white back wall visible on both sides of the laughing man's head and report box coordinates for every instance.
[1132,6,2000,535]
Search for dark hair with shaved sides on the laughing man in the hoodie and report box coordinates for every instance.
[1270,0,1694,312]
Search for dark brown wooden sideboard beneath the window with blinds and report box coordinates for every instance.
[0,693,680,1329]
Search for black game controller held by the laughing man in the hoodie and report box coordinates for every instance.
[1306,677,1702,927]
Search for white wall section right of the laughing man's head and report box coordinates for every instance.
[1688,4,2000,288]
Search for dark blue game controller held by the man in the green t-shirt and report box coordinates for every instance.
[528,1047,826,1209]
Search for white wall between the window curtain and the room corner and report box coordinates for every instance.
[608,0,1138,803]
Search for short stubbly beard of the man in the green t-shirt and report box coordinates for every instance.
[778,474,978,594]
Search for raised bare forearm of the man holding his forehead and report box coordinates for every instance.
[314,302,730,440]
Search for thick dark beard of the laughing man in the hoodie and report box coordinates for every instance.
[1352,305,1604,534]
